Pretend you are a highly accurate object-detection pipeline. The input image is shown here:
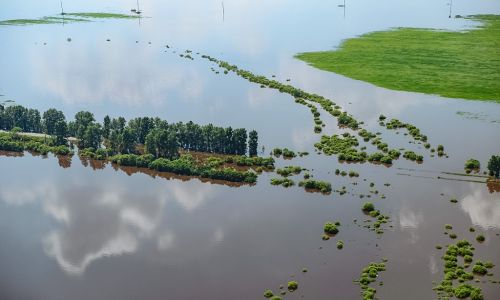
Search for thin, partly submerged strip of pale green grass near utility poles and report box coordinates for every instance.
[0,13,140,26]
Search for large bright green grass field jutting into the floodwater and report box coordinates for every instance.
[296,15,500,102]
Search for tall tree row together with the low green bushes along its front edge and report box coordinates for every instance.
[0,105,274,183]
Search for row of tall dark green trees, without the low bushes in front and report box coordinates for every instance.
[0,105,258,159]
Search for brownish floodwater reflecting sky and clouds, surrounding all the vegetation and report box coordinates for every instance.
[0,0,500,299]
